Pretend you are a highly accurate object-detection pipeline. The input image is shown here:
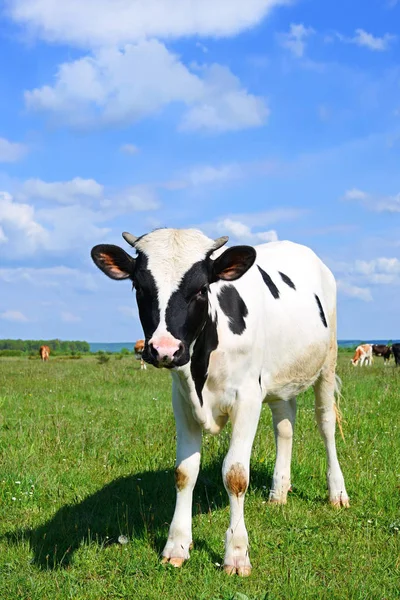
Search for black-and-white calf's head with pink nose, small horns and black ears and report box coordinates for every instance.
[92,229,256,368]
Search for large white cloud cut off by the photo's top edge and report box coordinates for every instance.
[7,0,288,48]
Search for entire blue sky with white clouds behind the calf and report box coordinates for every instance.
[0,0,400,342]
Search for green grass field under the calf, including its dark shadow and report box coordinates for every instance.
[0,354,400,600]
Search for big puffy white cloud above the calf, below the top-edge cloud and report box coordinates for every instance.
[25,40,269,132]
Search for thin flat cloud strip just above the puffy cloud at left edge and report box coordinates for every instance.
[19,177,104,204]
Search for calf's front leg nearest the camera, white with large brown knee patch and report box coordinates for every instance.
[222,390,261,577]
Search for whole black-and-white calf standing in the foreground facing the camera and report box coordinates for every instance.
[91,228,349,576]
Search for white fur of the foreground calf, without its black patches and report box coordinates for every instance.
[137,230,348,575]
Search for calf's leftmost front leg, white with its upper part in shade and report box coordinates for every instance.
[162,385,201,567]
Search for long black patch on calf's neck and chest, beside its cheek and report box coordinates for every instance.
[190,317,218,406]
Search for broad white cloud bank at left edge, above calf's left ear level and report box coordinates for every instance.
[0,172,160,259]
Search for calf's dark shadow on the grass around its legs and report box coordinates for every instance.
[3,458,276,570]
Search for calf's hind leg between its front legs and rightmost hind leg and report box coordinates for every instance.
[269,398,296,504]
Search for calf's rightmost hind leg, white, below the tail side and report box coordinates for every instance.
[314,371,349,507]
